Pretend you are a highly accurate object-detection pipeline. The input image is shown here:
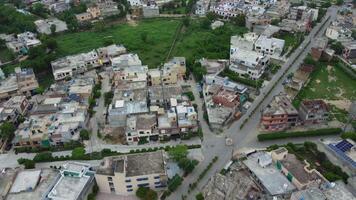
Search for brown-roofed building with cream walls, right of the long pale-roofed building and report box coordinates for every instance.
[271,147,329,190]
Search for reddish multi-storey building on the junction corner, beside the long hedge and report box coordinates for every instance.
[261,94,299,131]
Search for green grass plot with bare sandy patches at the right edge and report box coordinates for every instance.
[294,63,356,106]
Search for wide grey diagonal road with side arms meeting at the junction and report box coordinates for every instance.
[168,6,337,200]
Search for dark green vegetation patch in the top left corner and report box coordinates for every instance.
[0,4,36,33]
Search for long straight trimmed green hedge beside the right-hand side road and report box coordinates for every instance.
[257,128,342,141]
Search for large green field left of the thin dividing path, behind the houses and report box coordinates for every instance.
[56,19,180,68]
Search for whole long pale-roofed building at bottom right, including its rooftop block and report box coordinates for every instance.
[242,152,296,197]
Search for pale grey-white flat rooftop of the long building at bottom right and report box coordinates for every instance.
[243,152,296,195]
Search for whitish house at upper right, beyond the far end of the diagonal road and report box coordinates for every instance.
[325,24,352,42]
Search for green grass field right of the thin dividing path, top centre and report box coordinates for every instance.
[172,20,247,60]
